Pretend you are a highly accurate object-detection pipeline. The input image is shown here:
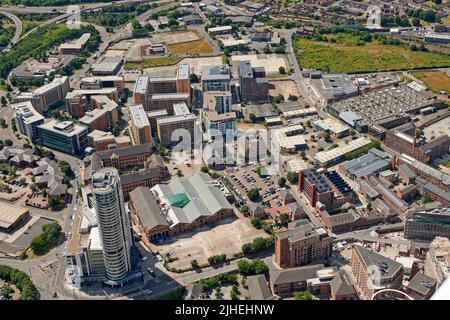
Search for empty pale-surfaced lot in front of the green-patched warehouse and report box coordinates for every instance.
[157,218,267,269]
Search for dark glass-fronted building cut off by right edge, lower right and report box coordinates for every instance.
[405,207,450,242]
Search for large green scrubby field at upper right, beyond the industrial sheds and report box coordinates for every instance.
[293,34,450,72]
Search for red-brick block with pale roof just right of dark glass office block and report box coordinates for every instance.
[80,96,119,132]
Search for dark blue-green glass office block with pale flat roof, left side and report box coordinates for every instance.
[38,120,88,155]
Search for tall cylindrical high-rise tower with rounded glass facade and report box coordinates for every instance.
[92,168,133,285]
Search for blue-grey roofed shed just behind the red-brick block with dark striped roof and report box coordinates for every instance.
[343,148,391,179]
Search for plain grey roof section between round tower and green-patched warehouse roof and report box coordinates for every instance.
[130,187,168,229]
